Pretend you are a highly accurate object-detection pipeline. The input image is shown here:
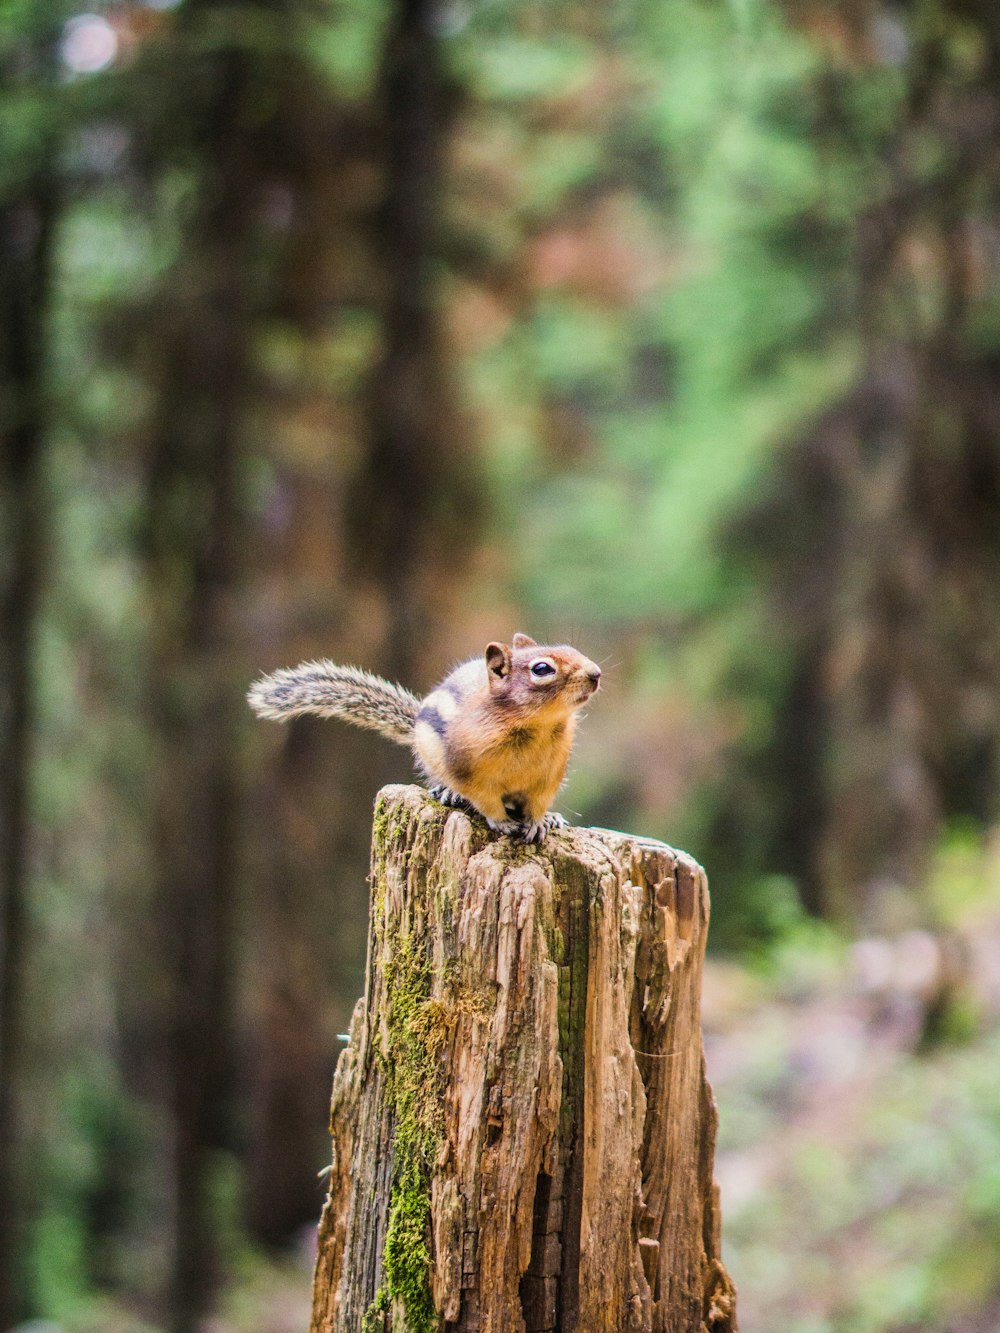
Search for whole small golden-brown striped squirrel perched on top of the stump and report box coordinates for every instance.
[247,635,601,844]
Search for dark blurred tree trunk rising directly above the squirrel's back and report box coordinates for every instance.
[347,0,483,680]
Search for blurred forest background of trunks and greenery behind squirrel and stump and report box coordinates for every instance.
[0,0,1000,1333]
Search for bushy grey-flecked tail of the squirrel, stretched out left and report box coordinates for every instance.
[247,661,420,745]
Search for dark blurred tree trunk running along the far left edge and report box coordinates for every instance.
[0,44,59,1328]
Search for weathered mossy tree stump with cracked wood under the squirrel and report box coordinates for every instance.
[311,786,736,1333]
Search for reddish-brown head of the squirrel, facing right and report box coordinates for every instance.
[485,635,601,713]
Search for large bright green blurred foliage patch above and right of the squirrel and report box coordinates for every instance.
[458,3,853,663]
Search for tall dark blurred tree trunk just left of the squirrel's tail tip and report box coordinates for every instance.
[145,15,261,1317]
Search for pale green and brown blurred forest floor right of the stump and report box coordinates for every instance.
[704,920,1000,1333]
